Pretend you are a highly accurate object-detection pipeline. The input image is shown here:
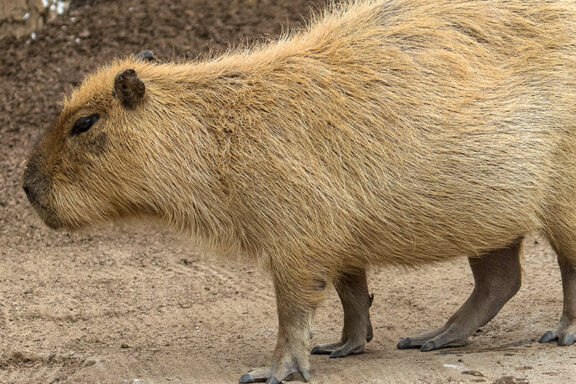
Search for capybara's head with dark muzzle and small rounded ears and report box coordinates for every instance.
[23,52,183,229]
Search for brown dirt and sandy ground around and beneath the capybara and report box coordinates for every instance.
[0,0,576,384]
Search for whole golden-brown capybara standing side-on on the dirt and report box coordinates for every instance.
[24,0,576,383]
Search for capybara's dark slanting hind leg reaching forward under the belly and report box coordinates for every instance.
[398,241,521,352]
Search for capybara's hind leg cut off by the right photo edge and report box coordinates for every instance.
[540,233,576,345]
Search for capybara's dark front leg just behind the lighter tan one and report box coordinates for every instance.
[311,269,373,357]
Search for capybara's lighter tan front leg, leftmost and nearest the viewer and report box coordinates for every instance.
[240,263,326,384]
